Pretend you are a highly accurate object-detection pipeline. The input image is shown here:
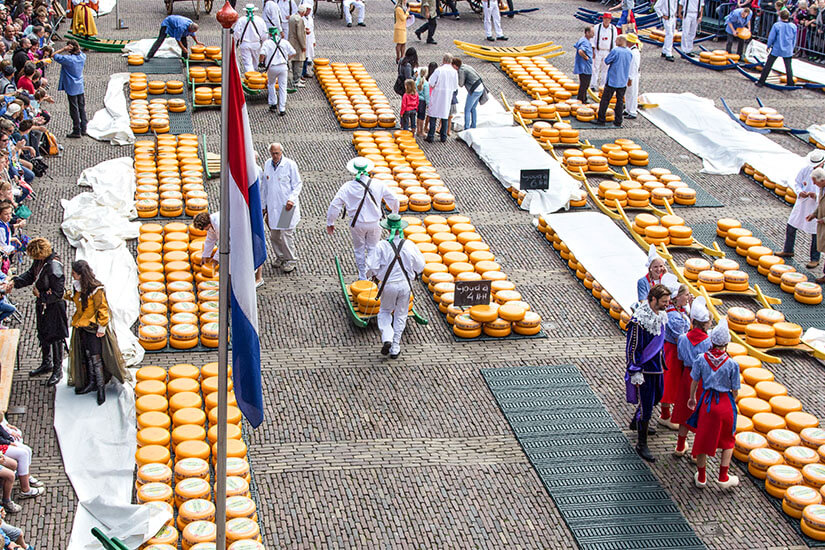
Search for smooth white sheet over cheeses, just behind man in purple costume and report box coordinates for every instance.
[544,212,647,313]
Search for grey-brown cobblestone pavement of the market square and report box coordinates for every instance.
[4,0,825,549]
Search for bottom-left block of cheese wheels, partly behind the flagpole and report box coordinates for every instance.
[135,363,264,550]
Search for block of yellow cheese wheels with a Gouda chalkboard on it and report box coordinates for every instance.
[412,215,541,338]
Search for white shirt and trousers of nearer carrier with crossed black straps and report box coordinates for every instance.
[367,238,424,355]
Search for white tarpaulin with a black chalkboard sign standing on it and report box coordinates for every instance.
[458,126,580,215]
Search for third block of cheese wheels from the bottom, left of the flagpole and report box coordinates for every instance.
[134,134,209,218]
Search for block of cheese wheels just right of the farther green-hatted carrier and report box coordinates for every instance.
[352,130,455,212]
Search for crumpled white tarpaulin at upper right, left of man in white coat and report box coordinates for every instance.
[640,93,804,190]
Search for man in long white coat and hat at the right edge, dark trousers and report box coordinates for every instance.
[776,149,825,269]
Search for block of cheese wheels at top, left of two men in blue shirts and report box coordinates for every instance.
[501,56,579,102]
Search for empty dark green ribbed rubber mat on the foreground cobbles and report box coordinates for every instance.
[481,365,705,550]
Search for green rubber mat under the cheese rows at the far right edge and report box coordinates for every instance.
[691,223,825,329]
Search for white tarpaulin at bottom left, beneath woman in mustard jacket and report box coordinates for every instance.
[54,378,170,550]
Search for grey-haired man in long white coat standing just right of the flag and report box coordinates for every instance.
[261,143,303,273]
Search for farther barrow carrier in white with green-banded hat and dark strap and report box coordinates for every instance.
[327,157,398,280]
